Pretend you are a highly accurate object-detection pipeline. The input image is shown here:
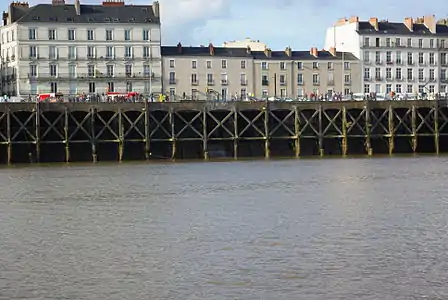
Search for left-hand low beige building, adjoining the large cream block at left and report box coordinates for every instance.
[162,43,254,100]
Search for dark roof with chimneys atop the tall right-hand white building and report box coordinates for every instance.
[358,21,448,36]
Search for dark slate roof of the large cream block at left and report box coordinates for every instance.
[10,4,160,24]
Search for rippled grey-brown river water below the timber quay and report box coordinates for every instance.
[0,157,448,300]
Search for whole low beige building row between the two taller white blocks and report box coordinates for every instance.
[162,44,362,100]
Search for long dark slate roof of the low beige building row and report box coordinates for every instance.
[162,46,358,60]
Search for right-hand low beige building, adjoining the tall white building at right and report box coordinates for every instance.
[253,47,361,98]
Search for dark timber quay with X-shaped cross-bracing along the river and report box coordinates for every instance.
[0,100,448,164]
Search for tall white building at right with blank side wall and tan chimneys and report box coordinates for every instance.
[325,15,448,94]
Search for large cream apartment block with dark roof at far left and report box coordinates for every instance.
[0,0,162,96]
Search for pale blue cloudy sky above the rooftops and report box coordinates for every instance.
[0,0,448,50]
